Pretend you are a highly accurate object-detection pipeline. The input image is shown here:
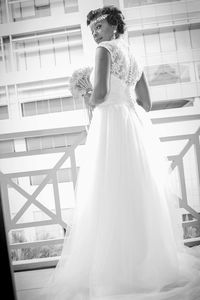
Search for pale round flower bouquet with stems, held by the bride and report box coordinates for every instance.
[69,67,92,122]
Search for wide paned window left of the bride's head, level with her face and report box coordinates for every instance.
[12,27,83,72]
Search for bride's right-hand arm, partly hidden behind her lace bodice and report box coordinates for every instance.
[135,72,152,112]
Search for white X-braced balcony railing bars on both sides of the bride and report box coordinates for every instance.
[0,113,200,269]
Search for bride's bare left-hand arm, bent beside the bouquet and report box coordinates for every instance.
[86,47,111,106]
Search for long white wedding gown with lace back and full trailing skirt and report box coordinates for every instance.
[42,38,200,300]
